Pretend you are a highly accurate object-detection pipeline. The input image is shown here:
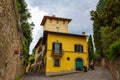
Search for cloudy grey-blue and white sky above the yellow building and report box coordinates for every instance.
[25,0,98,54]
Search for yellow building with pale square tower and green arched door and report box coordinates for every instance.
[36,16,88,76]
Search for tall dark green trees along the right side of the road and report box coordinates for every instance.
[91,0,120,57]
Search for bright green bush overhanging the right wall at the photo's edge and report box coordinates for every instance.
[107,41,120,60]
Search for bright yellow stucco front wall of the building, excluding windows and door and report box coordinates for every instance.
[43,32,88,76]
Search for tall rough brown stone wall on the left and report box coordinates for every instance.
[0,0,23,80]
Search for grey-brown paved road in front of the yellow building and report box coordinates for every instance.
[25,67,114,80]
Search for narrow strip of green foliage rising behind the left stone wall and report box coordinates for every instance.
[16,0,32,66]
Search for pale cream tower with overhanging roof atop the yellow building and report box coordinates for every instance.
[41,15,71,33]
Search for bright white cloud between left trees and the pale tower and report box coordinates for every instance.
[28,6,47,54]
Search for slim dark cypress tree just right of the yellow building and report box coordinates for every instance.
[88,35,94,61]
